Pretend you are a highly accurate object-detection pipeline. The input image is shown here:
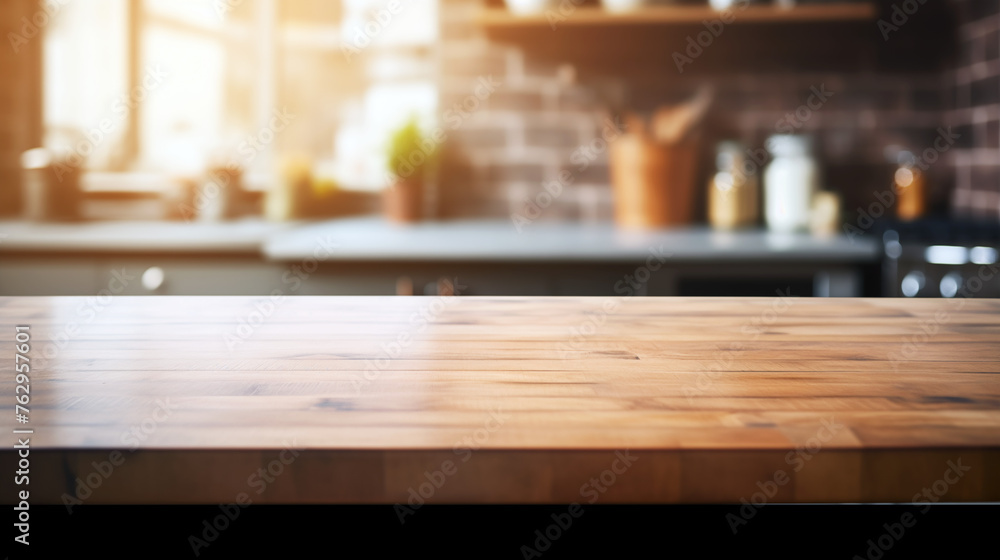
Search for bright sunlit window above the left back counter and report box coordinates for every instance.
[44,0,437,190]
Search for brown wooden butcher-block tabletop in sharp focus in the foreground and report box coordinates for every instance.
[0,296,1000,505]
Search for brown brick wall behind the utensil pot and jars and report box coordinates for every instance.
[440,0,1000,223]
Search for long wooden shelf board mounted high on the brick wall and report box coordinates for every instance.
[478,2,877,29]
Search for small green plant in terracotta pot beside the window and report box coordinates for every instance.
[384,117,438,222]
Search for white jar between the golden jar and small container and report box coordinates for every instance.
[764,134,819,232]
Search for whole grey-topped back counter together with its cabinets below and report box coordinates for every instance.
[0,216,881,297]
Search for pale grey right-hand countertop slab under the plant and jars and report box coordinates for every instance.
[263,217,879,262]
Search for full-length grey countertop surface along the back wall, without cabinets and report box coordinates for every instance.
[0,216,879,262]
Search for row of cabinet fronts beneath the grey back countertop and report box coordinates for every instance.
[0,255,878,297]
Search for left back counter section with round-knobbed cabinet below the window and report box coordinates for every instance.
[0,220,295,295]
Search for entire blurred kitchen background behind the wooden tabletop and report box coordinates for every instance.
[0,0,1000,297]
